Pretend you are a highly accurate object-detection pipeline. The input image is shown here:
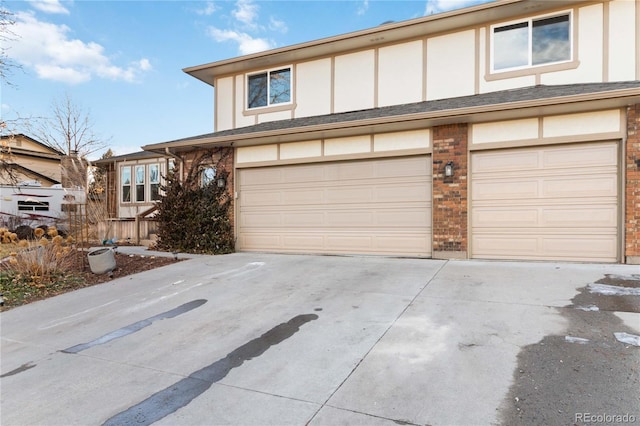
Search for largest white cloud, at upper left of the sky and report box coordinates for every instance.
[8,12,151,84]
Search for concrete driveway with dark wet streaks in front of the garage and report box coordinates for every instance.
[0,253,640,426]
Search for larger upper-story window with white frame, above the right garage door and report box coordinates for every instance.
[491,13,572,71]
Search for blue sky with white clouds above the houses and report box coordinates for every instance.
[0,0,487,159]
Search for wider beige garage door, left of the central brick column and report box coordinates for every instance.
[237,156,431,257]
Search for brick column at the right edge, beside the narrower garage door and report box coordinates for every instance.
[624,104,640,265]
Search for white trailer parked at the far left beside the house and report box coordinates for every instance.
[0,182,86,229]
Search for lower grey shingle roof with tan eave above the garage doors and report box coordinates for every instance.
[142,80,640,152]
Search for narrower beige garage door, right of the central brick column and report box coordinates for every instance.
[471,142,618,262]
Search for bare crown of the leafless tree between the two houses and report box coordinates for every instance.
[32,94,106,157]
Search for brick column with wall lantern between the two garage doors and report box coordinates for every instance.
[432,124,468,259]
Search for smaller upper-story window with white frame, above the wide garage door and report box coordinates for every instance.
[247,67,291,109]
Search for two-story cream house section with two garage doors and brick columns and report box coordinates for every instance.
[143,0,640,263]
